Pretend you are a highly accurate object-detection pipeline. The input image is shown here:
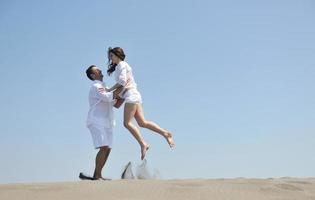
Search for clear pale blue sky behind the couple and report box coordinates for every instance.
[0,0,315,183]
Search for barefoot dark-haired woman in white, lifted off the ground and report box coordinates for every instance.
[107,47,175,160]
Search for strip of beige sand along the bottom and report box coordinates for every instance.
[0,178,315,200]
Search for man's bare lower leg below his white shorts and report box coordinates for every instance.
[93,146,111,179]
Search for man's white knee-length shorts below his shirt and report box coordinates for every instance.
[88,124,113,149]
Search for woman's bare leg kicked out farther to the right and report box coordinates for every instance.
[135,104,175,148]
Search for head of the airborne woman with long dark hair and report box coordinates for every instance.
[107,47,126,75]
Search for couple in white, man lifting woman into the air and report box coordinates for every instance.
[86,47,175,180]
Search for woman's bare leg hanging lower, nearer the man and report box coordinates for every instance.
[124,103,149,160]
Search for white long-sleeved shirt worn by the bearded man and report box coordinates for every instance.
[86,80,116,128]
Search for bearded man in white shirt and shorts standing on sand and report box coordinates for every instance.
[80,65,122,180]
